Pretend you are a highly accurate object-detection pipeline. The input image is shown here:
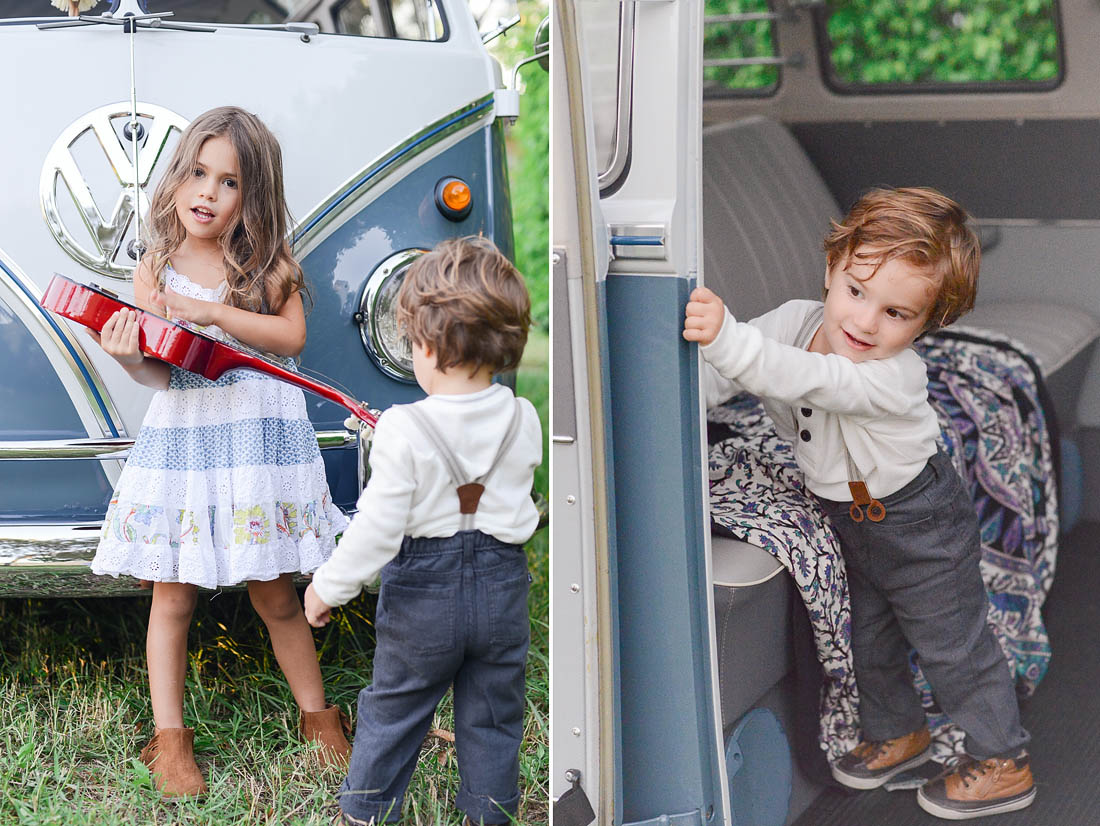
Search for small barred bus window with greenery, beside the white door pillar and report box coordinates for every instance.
[703,0,780,98]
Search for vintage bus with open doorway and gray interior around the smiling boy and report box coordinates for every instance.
[551,0,1100,826]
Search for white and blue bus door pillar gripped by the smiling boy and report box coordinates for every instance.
[550,0,733,826]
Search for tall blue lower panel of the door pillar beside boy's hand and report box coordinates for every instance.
[607,275,724,823]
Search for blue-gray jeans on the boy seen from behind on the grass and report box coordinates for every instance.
[339,530,530,824]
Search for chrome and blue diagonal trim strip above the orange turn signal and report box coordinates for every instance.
[292,92,493,251]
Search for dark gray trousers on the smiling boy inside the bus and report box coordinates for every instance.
[818,451,1031,759]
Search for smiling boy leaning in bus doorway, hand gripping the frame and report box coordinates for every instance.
[683,188,1035,819]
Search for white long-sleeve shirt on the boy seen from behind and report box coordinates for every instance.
[314,384,542,606]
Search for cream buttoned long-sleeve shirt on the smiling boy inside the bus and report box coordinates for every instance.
[700,300,939,502]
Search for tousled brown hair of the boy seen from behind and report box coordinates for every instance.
[397,235,531,373]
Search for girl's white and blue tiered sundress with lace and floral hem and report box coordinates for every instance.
[91,267,348,588]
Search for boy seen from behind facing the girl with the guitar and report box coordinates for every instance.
[306,236,542,824]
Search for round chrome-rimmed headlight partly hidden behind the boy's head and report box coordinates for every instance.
[355,250,427,383]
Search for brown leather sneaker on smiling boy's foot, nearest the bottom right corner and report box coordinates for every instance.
[916,751,1035,821]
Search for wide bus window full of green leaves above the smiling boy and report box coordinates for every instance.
[817,0,1064,93]
